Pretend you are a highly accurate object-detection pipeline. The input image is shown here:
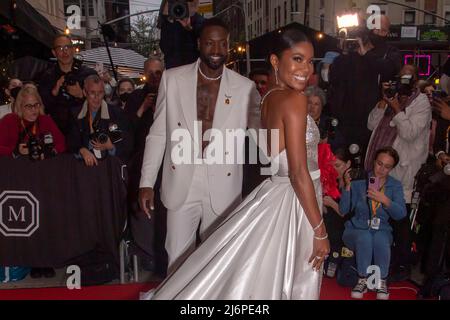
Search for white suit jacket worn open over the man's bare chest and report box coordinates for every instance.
[140,60,260,213]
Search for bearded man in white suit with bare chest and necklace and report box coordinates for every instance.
[139,18,260,270]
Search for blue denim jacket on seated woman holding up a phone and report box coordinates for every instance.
[339,176,406,231]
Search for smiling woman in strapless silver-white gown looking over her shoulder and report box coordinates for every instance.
[144,29,329,300]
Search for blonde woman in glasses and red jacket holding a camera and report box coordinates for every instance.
[0,86,66,160]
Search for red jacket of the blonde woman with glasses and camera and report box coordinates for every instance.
[0,113,66,156]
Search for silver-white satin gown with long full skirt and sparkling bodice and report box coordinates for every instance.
[141,116,322,300]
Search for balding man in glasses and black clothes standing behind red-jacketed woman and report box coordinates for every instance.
[39,35,96,136]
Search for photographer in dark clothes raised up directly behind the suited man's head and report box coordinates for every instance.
[158,0,204,69]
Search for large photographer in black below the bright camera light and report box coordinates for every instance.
[328,15,401,153]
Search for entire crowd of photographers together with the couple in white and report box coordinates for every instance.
[0,11,450,300]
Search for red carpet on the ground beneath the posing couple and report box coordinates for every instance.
[0,278,417,300]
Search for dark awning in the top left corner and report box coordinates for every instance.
[0,0,57,48]
